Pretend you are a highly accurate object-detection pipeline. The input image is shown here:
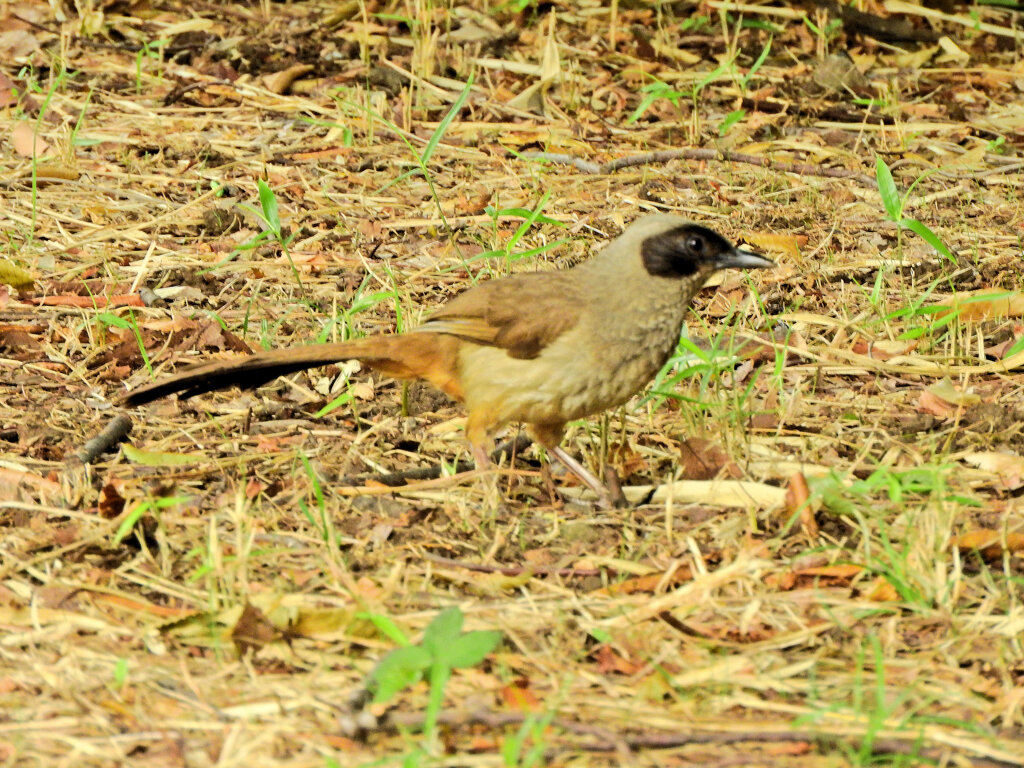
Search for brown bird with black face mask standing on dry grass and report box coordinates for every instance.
[122,213,774,506]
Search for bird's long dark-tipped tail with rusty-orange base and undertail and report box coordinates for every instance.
[123,333,463,406]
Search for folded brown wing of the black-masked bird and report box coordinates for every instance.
[421,272,585,359]
